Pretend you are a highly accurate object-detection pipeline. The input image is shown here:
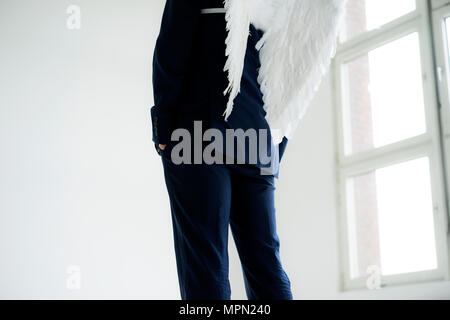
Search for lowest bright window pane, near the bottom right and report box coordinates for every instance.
[346,158,437,279]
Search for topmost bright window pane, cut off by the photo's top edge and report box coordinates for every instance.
[340,0,416,41]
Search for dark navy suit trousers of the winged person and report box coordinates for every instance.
[158,146,292,300]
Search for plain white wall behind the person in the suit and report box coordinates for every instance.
[0,0,450,299]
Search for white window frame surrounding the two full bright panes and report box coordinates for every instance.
[332,0,450,291]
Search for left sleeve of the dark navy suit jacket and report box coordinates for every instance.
[151,0,200,144]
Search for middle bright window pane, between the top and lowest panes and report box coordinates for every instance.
[343,33,426,155]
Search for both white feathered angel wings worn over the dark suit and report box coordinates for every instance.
[225,0,347,144]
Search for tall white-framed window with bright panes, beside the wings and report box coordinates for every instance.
[334,0,450,290]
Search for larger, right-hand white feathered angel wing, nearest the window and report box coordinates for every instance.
[257,0,346,143]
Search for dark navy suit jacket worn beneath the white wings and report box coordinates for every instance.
[151,0,287,176]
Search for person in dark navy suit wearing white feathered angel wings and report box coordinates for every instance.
[151,0,344,300]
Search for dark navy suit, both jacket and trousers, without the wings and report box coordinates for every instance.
[151,0,292,299]
